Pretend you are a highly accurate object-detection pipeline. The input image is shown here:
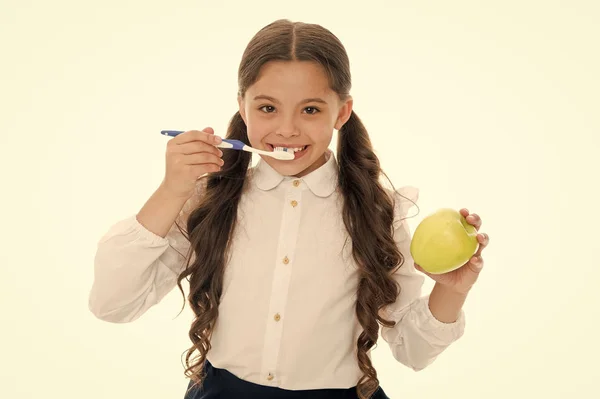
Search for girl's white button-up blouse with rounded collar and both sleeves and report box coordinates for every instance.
[89,151,465,390]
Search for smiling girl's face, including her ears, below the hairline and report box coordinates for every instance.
[238,61,352,177]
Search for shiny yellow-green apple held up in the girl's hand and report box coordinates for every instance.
[410,208,479,274]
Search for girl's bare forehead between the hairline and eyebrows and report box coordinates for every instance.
[248,61,334,98]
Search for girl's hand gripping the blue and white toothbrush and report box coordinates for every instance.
[162,127,224,198]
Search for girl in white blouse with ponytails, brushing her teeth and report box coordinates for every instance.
[89,20,488,399]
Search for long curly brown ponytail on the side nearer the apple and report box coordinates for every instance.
[338,111,404,398]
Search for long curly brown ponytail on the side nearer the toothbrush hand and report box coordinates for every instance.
[177,112,252,396]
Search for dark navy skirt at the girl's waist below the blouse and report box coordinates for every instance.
[184,360,389,399]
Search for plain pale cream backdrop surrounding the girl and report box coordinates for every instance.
[0,0,600,399]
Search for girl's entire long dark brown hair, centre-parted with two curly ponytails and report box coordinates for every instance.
[177,20,412,399]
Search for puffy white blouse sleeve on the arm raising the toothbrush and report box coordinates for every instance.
[88,187,202,323]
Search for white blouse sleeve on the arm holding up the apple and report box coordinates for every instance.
[381,187,465,371]
